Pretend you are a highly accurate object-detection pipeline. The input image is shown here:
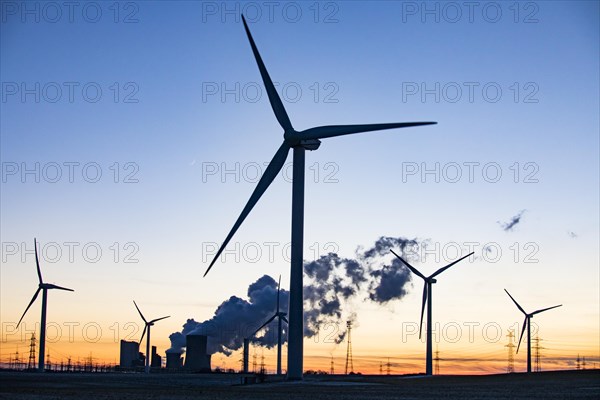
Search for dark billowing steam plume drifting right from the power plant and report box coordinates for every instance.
[167,236,426,355]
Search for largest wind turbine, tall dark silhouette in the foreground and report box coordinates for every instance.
[204,15,435,380]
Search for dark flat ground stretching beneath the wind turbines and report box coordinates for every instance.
[0,370,600,400]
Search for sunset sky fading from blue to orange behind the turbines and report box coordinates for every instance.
[0,1,600,373]
